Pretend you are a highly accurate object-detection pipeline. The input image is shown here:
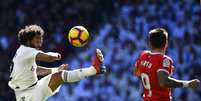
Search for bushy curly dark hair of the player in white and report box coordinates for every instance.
[18,25,44,45]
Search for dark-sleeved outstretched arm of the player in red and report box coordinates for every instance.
[157,71,200,89]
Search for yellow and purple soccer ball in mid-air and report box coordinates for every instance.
[68,26,89,47]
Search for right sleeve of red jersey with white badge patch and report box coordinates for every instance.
[157,57,173,75]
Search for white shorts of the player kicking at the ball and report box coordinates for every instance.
[15,74,61,101]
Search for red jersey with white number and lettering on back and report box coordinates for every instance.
[135,51,173,101]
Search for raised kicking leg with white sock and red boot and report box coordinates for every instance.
[48,49,106,91]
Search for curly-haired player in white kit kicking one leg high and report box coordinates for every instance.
[8,25,106,101]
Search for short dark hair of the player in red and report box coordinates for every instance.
[149,28,168,48]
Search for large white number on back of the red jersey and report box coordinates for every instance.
[141,73,152,97]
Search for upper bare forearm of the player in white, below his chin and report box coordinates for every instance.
[36,52,61,62]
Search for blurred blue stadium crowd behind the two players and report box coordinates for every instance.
[0,0,201,101]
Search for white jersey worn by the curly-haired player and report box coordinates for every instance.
[8,45,42,91]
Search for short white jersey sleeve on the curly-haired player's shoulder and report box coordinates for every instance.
[23,47,42,60]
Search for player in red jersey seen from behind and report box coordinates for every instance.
[134,28,200,101]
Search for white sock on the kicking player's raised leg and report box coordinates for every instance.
[61,66,96,82]
